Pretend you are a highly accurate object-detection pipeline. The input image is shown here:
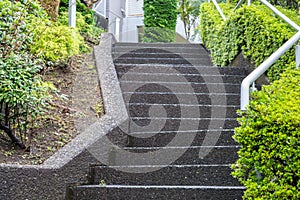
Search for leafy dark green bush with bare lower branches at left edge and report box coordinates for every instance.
[0,0,49,148]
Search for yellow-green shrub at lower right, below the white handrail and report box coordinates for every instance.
[233,67,300,200]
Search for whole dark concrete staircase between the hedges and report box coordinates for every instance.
[67,43,247,200]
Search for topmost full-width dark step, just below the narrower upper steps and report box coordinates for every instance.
[115,64,249,76]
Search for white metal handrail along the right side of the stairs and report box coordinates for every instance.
[212,0,300,110]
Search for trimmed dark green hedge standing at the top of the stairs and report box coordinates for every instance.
[142,0,177,42]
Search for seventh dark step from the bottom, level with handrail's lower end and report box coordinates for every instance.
[123,92,240,106]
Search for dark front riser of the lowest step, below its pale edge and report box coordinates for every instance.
[68,186,244,200]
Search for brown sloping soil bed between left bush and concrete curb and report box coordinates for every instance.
[0,54,104,165]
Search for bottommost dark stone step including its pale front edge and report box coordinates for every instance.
[68,184,244,200]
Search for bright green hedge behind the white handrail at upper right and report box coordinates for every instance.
[200,3,299,80]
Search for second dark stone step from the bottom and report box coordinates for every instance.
[90,164,240,186]
